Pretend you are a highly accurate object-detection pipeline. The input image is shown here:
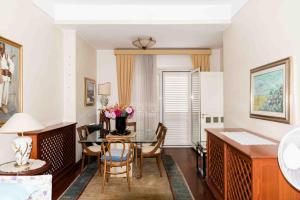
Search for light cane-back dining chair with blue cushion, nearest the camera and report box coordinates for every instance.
[101,137,134,193]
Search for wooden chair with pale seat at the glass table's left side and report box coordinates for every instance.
[77,126,101,175]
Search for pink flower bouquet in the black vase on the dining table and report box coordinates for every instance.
[104,105,134,119]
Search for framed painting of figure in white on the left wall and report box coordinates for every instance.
[0,36,23,126]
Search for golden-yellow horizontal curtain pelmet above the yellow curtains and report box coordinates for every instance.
[115,49,211,55]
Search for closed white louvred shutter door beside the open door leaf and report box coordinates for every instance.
[162,71,190,146]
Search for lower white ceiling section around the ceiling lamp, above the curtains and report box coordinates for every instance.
[66,24,227,49]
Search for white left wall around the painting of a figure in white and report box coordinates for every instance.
[0,0,63,163]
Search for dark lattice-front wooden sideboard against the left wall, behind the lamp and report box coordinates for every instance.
[24,123,76,183]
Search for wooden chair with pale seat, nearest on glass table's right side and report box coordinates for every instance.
[140,125,167,177]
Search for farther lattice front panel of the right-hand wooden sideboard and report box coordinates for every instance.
[207,134,225,199]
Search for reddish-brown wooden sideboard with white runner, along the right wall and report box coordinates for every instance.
[206,129,300,200]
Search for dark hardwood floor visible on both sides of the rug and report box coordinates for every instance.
[52,148,214,200]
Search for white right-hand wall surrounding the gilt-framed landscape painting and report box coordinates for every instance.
[223,0,300,139]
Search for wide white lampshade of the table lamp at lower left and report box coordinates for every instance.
[0,113,45,133]
